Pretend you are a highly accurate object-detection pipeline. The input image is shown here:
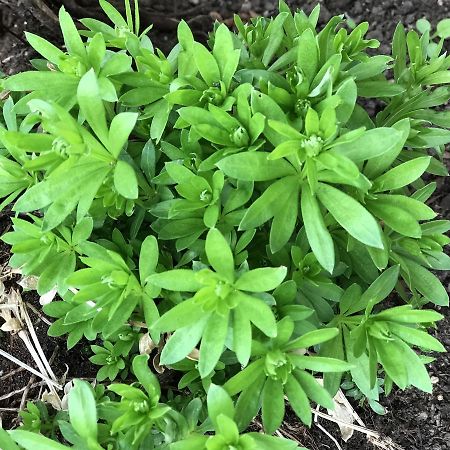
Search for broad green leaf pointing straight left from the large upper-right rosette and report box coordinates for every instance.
[216,152,295,181]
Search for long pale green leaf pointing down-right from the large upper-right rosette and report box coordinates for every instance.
[317,183,383,248]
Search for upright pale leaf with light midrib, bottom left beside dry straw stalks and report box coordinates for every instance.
[69,380,97,440]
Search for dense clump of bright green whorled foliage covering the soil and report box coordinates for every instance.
[0,0,450,450]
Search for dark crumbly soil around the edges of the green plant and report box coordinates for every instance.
[0,0,450,450]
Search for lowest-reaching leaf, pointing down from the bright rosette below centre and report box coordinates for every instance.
[198,311,229,378]
